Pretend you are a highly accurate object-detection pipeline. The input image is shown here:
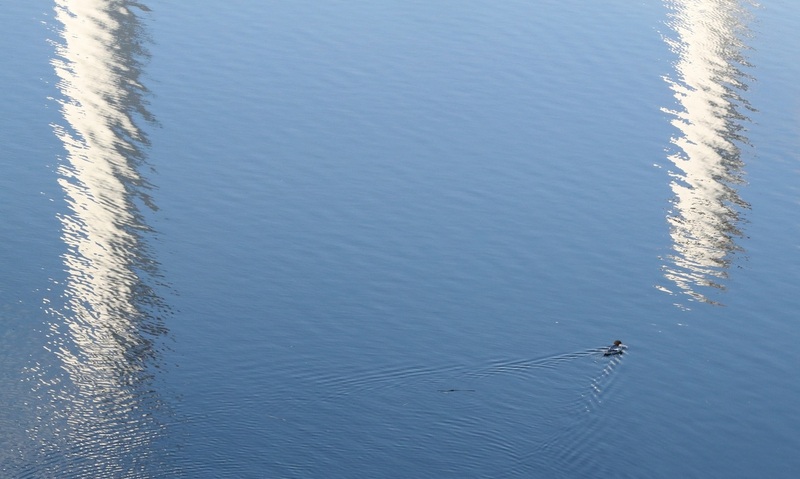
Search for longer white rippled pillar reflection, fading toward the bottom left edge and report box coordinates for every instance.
[31,0,175,477]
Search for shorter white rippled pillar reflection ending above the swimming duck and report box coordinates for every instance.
[663,0,751,304]
